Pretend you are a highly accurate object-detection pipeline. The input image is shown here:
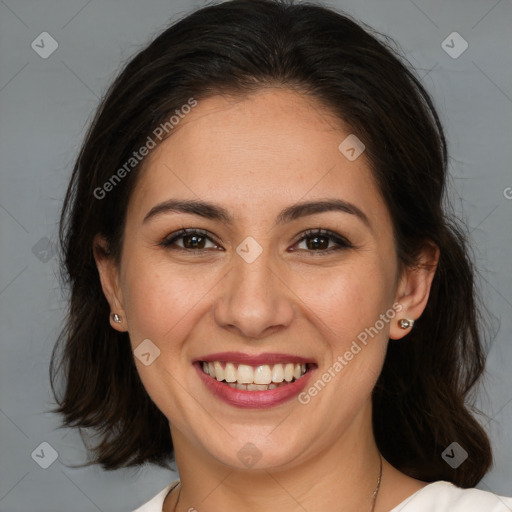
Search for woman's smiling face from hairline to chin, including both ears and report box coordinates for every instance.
[98,89,429,468]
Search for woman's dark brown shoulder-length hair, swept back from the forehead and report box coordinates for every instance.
[50,0,492,487]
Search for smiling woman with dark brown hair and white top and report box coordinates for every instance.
[52,0,512,512]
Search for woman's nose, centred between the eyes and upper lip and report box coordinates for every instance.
[214,251,294,339]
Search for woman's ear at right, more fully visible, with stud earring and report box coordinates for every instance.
[389,242,439,340]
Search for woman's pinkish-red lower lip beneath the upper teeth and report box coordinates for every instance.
[194,363,314,409]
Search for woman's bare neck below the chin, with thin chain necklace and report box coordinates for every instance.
[164,406,386,512]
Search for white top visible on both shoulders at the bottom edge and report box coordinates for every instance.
[133,480,512,512]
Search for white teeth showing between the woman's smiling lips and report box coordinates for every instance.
[201,361,308,391]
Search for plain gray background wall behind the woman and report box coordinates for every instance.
[0,0,512,512]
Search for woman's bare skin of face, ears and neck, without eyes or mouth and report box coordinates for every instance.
[95,89,438,512]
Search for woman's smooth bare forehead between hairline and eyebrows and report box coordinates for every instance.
[130,89,384,227]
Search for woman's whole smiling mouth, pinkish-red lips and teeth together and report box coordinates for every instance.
[194,352,317,409]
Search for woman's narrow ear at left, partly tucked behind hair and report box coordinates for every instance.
[93,235,127,332]
